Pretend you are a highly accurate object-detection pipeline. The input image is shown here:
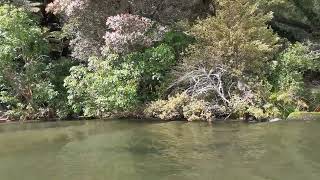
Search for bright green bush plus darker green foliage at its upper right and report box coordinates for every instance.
[65,44,175,117]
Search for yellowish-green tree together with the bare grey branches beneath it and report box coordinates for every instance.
[170,0,279,118]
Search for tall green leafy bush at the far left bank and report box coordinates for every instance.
[0,5,72,120]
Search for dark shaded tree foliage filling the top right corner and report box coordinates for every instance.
[258,0,320,41]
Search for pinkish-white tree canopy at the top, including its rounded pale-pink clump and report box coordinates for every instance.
[46,0,208,61]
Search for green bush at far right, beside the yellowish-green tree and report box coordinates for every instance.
[269,43,320,116]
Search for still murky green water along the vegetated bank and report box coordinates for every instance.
[0,120,320,180]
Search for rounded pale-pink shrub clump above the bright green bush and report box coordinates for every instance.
[104,14,166,54]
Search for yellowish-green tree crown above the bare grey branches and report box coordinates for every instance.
[184,0,278,77]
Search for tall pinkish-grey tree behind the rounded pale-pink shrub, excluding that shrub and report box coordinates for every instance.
[47,0,209,61]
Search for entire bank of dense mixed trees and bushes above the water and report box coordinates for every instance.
[0,0,320,121]
